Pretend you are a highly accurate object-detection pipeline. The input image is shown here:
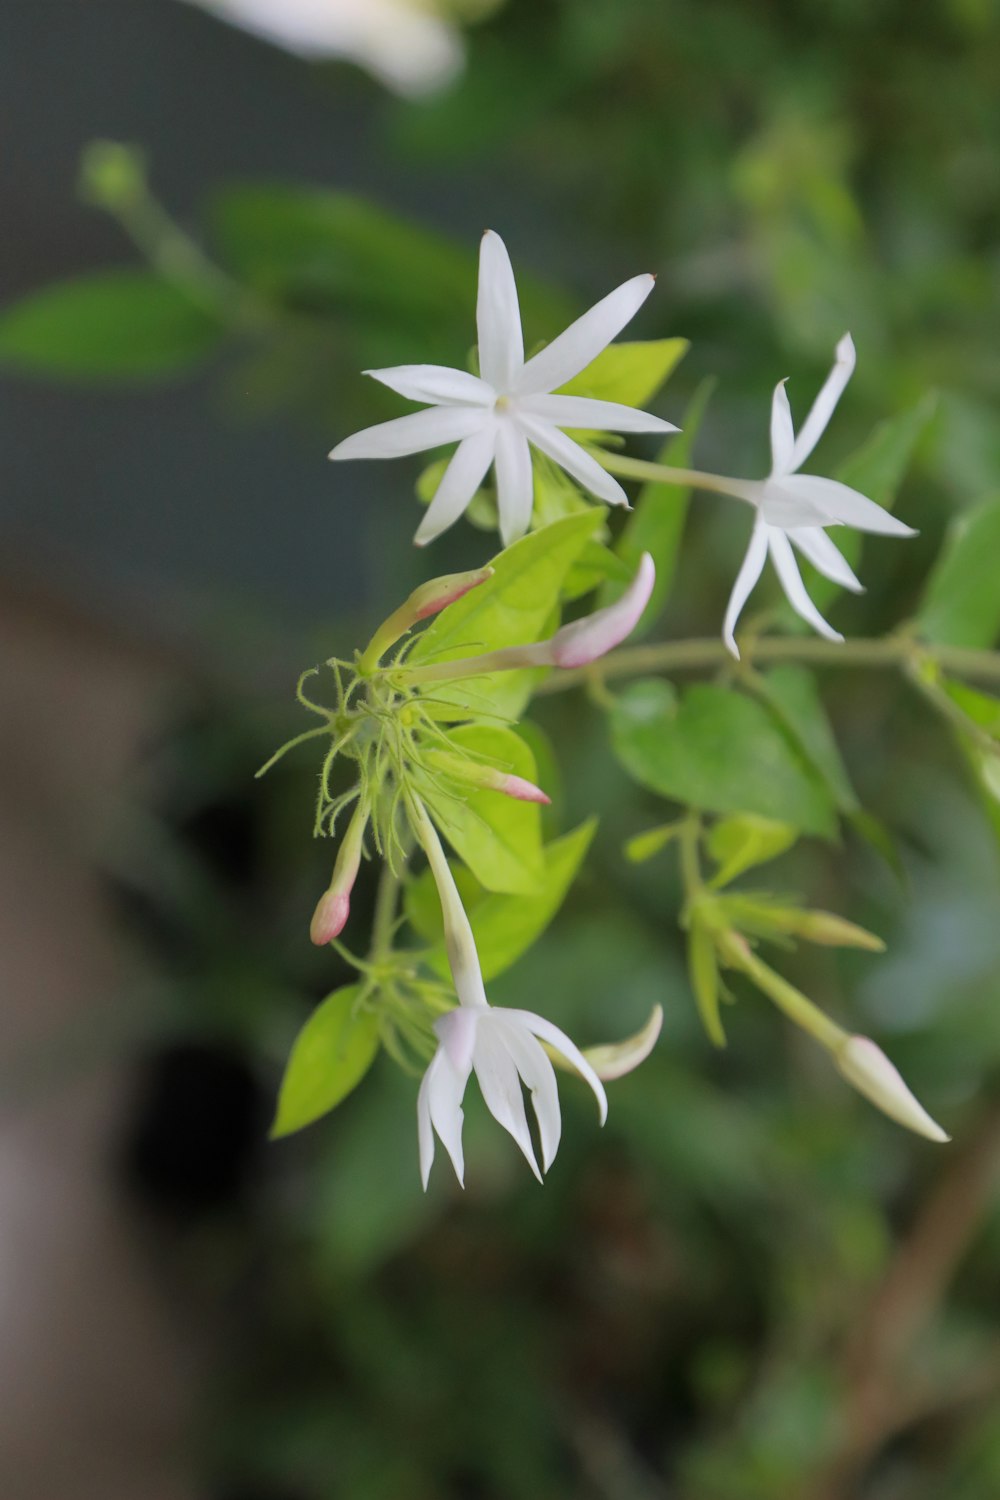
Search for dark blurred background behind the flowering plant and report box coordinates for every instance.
[0,0,1000,1500]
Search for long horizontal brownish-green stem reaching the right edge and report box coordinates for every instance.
[537,635,1000,695]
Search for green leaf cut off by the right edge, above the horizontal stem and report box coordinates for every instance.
[918,495,1000,647]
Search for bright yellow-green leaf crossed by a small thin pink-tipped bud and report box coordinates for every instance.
[420,725,544,894]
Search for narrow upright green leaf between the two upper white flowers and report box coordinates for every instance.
[600,380,715,639]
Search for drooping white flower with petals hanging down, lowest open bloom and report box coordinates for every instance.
[417,1002,607,1188]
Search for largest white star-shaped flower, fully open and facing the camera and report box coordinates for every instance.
[330,230,678,546]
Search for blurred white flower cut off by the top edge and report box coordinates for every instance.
[182,0,463,95]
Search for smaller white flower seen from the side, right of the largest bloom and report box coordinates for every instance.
[723,333,916,657]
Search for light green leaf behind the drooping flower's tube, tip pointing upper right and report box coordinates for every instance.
[406,818,597,981]
